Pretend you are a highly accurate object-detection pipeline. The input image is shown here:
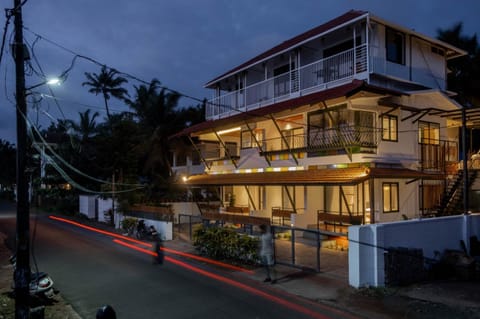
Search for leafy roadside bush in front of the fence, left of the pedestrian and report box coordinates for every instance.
[193,227,259,264]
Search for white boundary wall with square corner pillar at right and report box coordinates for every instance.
[348,214,480,288]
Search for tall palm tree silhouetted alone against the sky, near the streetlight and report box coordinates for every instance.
[82,66,128,120]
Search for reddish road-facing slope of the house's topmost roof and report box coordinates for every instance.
[205,10,368,87]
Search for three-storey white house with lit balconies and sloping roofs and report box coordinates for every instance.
[173,11,465,231]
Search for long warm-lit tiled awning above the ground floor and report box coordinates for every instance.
[184,167,444,186]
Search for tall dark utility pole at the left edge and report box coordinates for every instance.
[13,0,30,319]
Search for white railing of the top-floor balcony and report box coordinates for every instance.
[206,44,368,120]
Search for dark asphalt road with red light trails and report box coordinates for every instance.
[0,207,352,319]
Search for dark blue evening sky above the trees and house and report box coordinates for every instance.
[0,0,480,143]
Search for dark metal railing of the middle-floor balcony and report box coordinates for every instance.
[264,125,378,153]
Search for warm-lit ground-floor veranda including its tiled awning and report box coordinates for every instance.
[182,167,445,233]
